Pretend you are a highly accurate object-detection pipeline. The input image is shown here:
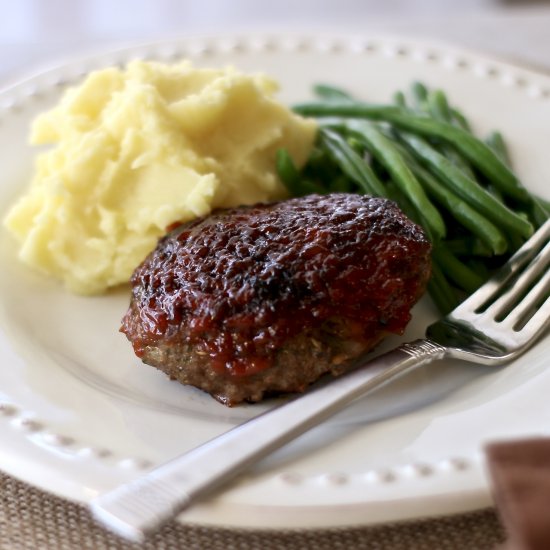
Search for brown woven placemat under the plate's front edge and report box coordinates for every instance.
[0,474,504,550]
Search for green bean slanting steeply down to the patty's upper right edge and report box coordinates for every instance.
[353,122,446,240]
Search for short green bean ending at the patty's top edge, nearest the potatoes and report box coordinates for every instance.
[320,128,385,197]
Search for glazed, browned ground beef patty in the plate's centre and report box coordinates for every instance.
[121,193,431,405]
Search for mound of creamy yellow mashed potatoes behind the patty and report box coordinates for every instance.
[5,61,316,294]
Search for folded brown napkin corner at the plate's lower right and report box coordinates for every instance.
[486,438,550,550]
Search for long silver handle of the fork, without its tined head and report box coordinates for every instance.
[90,340,446,541]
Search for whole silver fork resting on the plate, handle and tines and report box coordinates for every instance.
[90,220,550,541]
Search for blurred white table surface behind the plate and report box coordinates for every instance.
[0,0,550,82]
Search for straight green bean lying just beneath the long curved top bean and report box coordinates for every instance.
[399,132,533,238]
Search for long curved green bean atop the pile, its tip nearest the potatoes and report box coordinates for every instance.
[295,103,530,202]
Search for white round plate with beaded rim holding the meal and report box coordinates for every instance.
[0,32,550,528]
